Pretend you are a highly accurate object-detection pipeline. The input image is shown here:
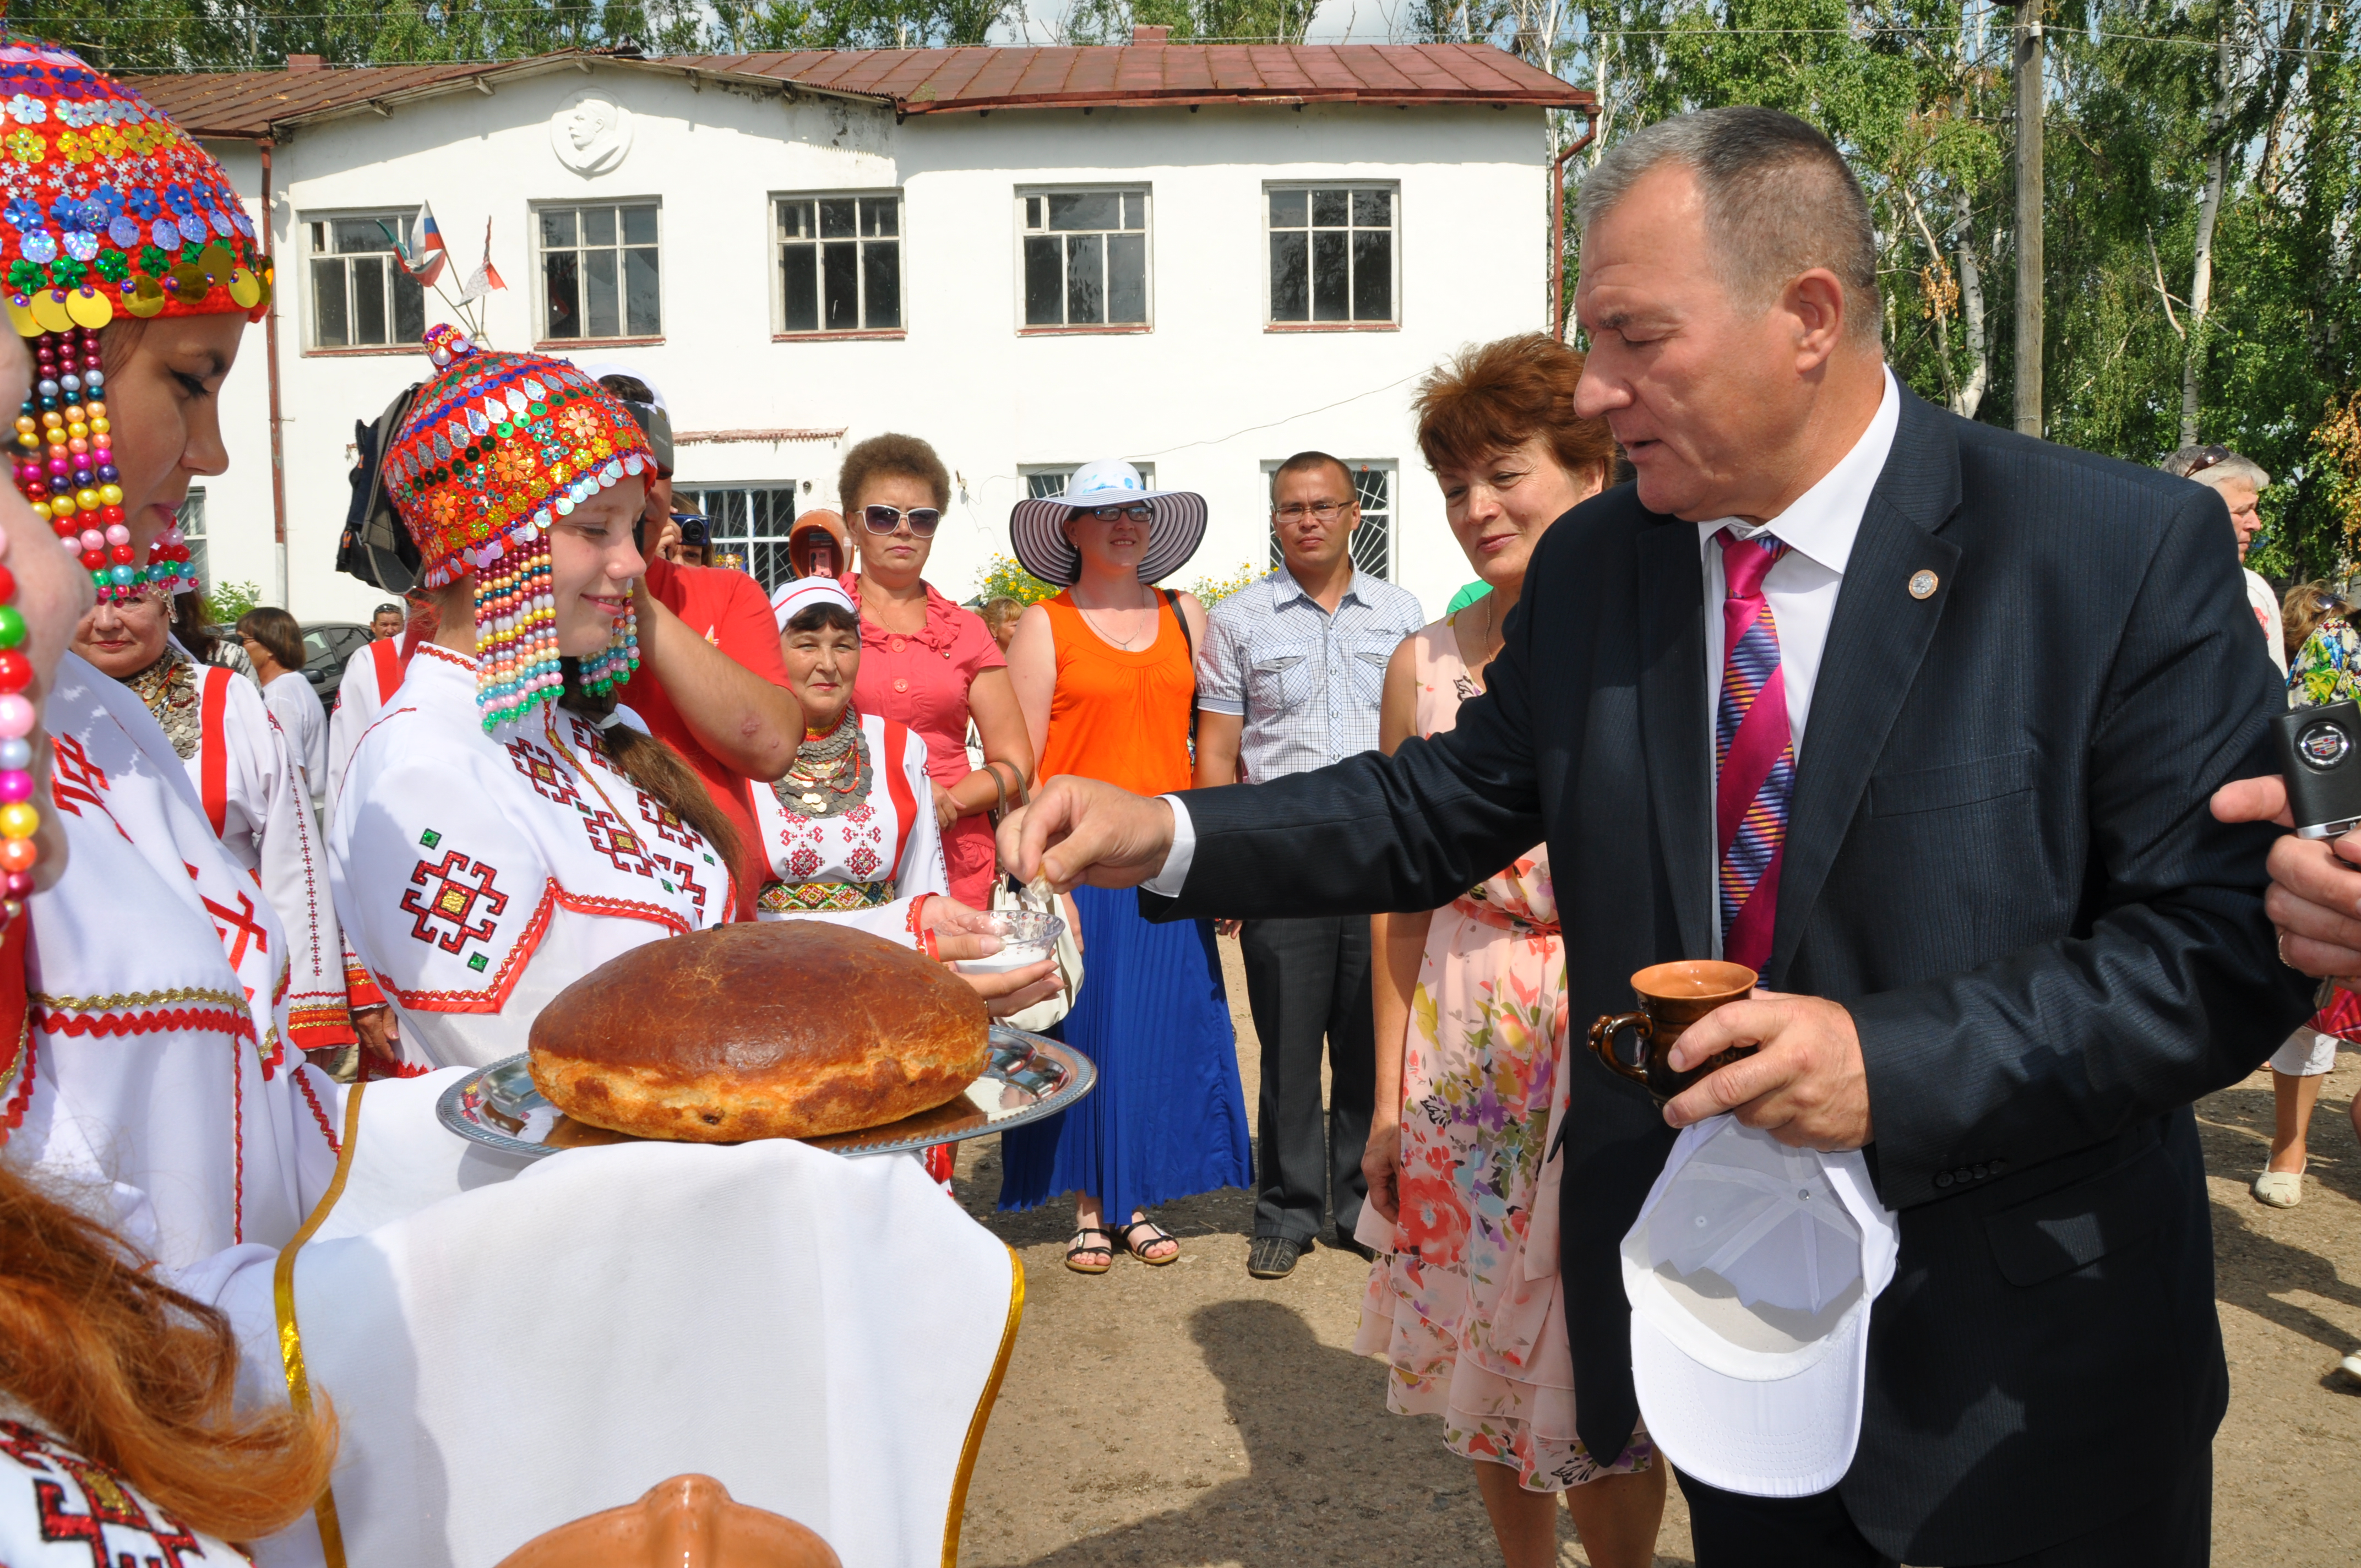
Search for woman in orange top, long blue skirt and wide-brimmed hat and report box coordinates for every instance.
[1001,463,1254,1273]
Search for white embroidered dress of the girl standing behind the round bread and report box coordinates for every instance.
[328,645,735,1068]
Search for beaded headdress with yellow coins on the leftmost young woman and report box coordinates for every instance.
[0,45,271,597]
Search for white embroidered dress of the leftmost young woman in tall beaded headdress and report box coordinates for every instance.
[0,654,338,1268]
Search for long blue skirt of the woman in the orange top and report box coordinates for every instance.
[1001,888,1254,1226]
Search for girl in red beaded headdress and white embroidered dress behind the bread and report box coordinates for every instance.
[328,326,737,1065]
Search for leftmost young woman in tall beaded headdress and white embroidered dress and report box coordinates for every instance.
[0,45,349,1266]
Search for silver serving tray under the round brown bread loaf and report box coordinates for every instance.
[434,1022,1098,1159]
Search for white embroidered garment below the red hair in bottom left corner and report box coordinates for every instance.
[0,1400,248,1568]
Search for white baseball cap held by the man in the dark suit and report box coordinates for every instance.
[1622,1114,1898,1497]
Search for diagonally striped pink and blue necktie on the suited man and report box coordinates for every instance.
[1714,529,1794,973]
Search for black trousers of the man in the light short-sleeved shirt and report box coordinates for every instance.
[1237,914,1377,1244]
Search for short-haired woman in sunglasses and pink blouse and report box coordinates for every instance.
[836,434,1034,909]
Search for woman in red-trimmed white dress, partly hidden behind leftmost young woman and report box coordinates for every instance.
[73,581,354,1051]
